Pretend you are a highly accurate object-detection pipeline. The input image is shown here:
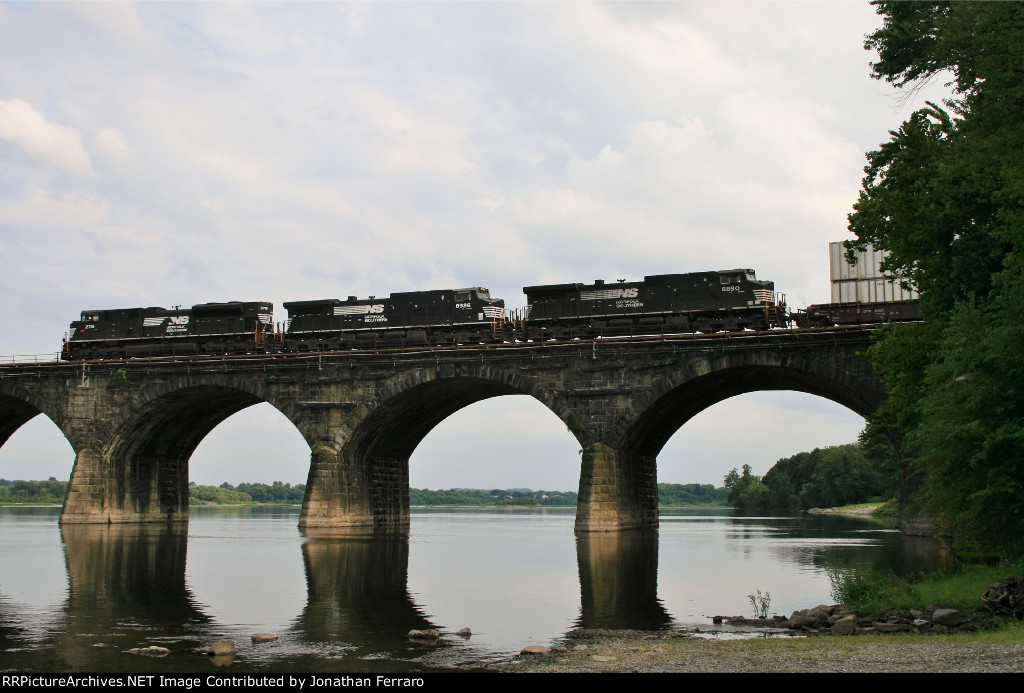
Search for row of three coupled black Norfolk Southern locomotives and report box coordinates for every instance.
[61,269,864,360]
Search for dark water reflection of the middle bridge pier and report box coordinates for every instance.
[297,530,436,648]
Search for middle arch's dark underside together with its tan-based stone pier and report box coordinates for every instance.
[300,363,579,531]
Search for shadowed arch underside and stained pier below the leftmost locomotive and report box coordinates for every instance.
[61,375,294,523]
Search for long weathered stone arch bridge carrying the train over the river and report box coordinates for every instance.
[0,328,886,532]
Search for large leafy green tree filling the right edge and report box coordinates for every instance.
[849,1,1024,554]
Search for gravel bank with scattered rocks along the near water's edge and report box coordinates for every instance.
[495,593,1024,673]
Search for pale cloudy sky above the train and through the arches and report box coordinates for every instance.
[0,0,944,490]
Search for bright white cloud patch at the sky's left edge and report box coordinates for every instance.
[0,98,96,178]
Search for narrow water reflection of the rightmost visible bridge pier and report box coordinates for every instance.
[577,529,672,630]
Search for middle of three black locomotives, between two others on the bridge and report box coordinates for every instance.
[282,287,506,351]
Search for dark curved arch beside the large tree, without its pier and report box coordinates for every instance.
[616,352,887,459]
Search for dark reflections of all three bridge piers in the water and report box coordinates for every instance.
[0,524,672,670]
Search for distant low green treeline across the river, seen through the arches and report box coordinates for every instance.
[0,477,729,507]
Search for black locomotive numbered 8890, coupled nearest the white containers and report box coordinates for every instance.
[516,269,786,341]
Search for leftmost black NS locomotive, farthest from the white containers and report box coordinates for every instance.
[61,301,273,360]
